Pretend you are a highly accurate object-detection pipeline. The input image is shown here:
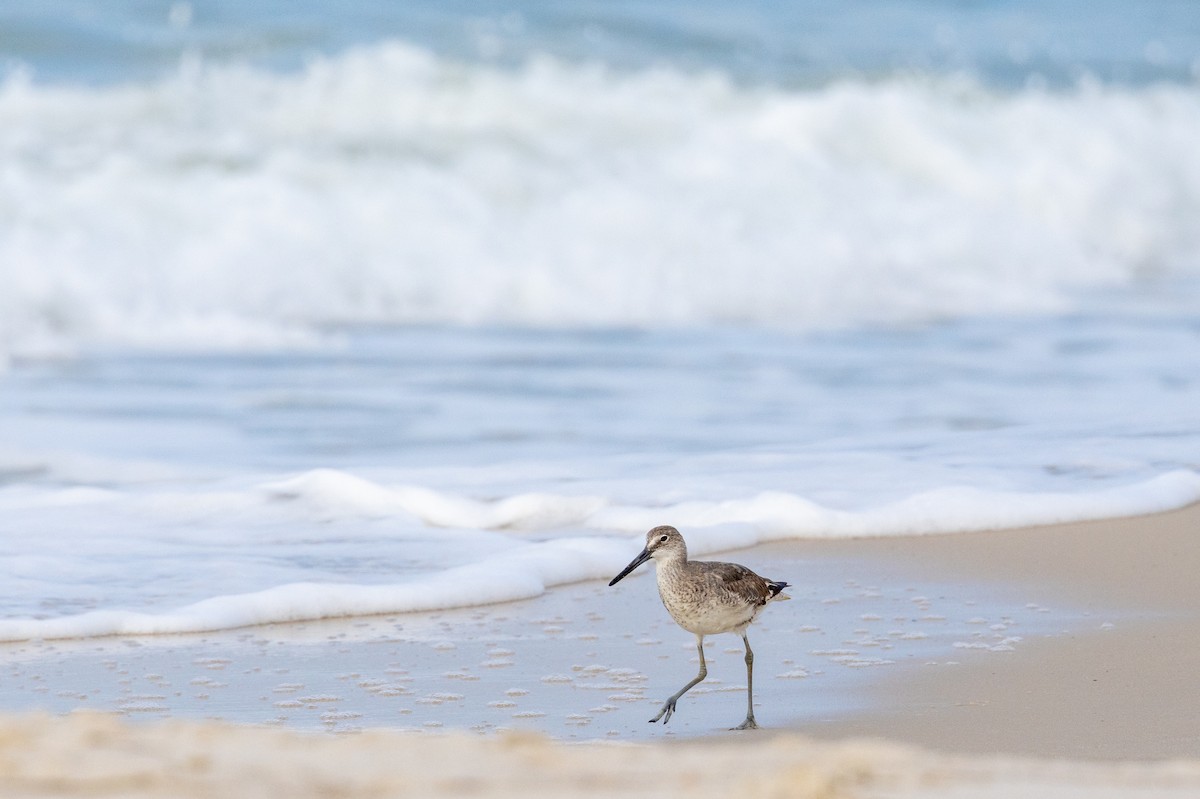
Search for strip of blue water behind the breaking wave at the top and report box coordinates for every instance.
[7,0,1200,88]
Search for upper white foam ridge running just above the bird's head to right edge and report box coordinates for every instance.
[262,469,1200,537]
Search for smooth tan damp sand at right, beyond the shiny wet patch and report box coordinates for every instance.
[805,505,1200,759]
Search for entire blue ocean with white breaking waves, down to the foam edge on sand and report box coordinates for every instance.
[0,0,1200,641]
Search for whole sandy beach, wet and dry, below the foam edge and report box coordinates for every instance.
[0,507,1200,798]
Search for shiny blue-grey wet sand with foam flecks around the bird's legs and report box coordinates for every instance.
[0,525,1075,741]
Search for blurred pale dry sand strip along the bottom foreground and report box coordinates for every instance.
[0,714,1200,799]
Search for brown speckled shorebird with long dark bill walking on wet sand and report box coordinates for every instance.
[608,524,792,729]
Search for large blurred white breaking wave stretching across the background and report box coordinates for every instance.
[0,43,1200,355]
